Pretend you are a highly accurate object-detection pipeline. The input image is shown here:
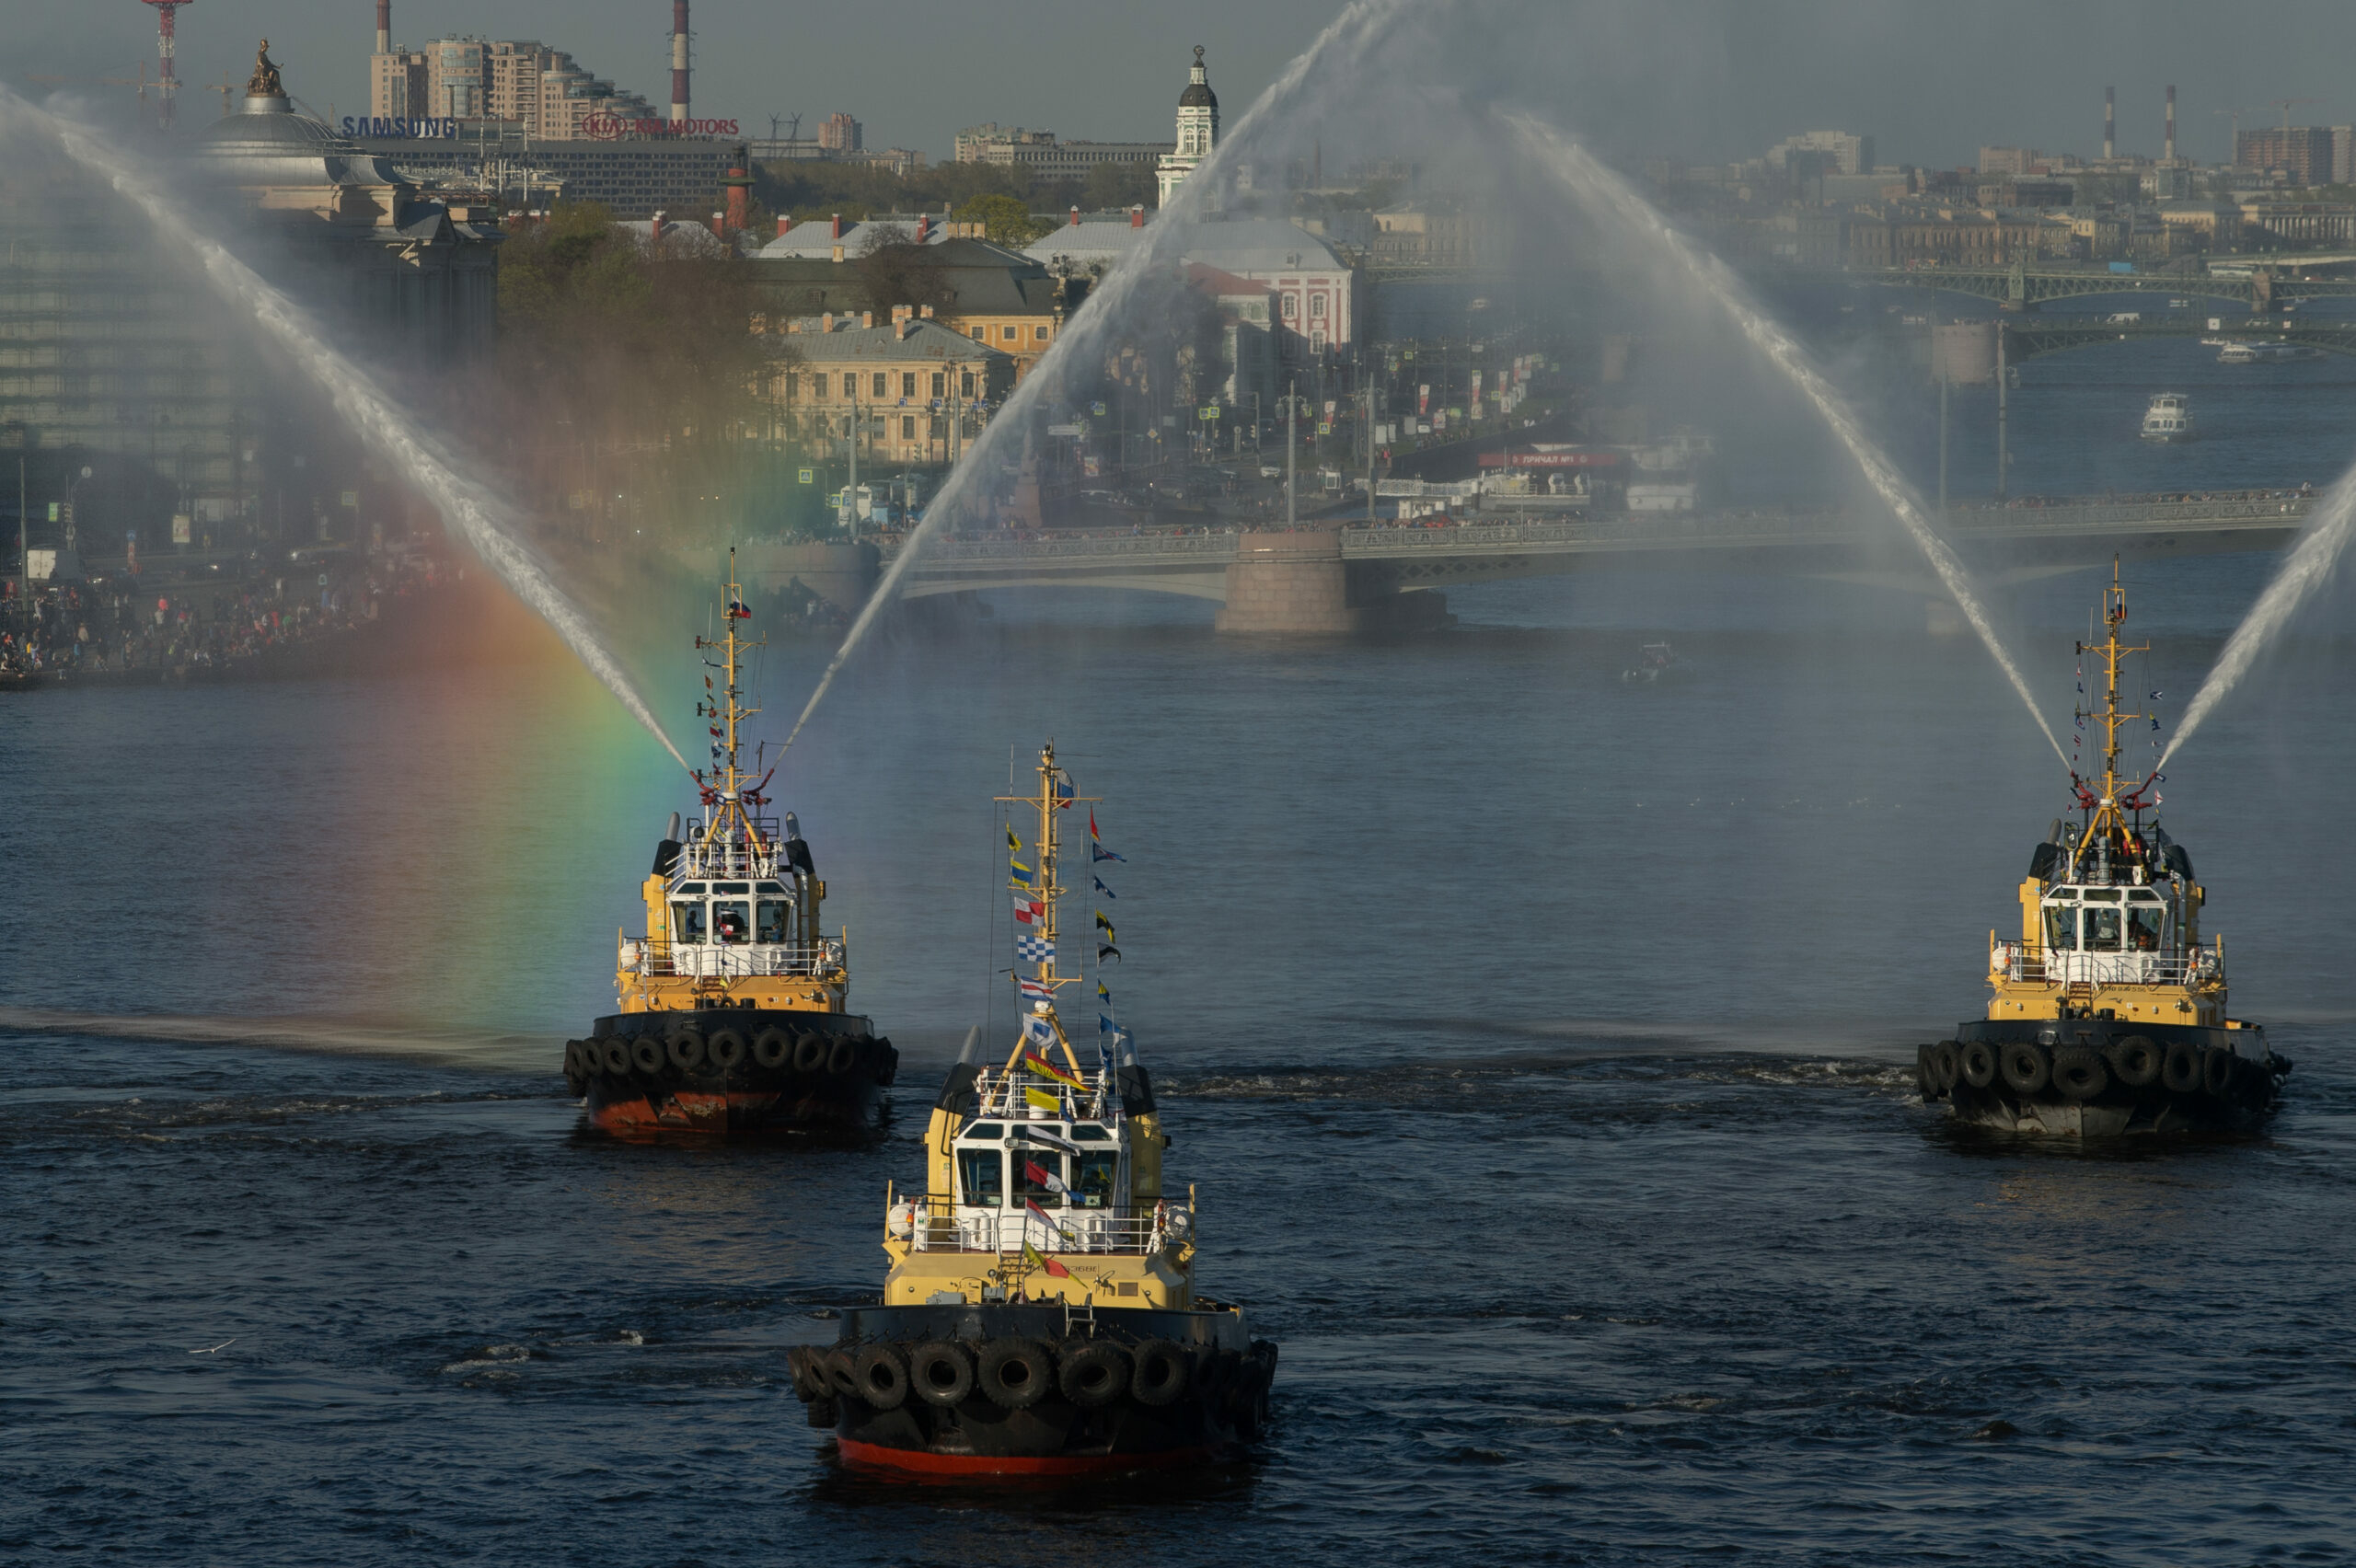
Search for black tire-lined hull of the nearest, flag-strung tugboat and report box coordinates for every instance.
[794,1302,1277,1481]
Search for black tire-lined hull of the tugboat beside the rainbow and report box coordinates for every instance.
[565,1008,900,1135]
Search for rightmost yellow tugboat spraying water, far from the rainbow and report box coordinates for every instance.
[1915,562,2290,1137]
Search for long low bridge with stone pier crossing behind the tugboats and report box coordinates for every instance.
[857,490,2314,631]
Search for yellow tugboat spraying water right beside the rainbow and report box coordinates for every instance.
[565,551,900,1133]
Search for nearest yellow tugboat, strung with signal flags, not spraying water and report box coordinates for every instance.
[791,746,1277,1479]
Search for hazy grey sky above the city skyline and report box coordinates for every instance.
[22,0,2356,165]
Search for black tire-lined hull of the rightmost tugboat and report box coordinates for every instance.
[1915,1017,2290,1137]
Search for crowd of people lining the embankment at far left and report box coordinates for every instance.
[0,558,453,680]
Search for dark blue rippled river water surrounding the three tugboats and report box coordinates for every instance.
[14,355,2356,1563]
